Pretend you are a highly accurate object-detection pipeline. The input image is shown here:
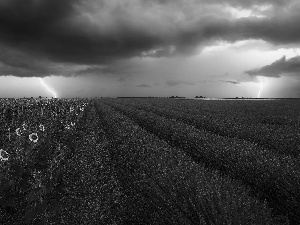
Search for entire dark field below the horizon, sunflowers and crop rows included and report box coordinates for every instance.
[0,98,300,225]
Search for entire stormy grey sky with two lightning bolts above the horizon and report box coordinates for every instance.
[0,0,300,98]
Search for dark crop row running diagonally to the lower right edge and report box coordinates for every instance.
[100,101,300,221]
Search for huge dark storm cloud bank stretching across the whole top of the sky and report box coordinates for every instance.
[0,0,300,76]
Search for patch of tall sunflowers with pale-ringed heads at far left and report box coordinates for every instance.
[0,99,90,224]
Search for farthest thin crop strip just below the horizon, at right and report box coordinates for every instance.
[135,99,300,126]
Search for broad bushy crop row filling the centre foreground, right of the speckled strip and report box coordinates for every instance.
[96,101,288,224]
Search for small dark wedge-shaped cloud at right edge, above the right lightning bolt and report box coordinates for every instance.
[245,56,300,77]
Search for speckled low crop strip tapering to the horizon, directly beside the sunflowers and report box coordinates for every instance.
[54,104,122,224]
